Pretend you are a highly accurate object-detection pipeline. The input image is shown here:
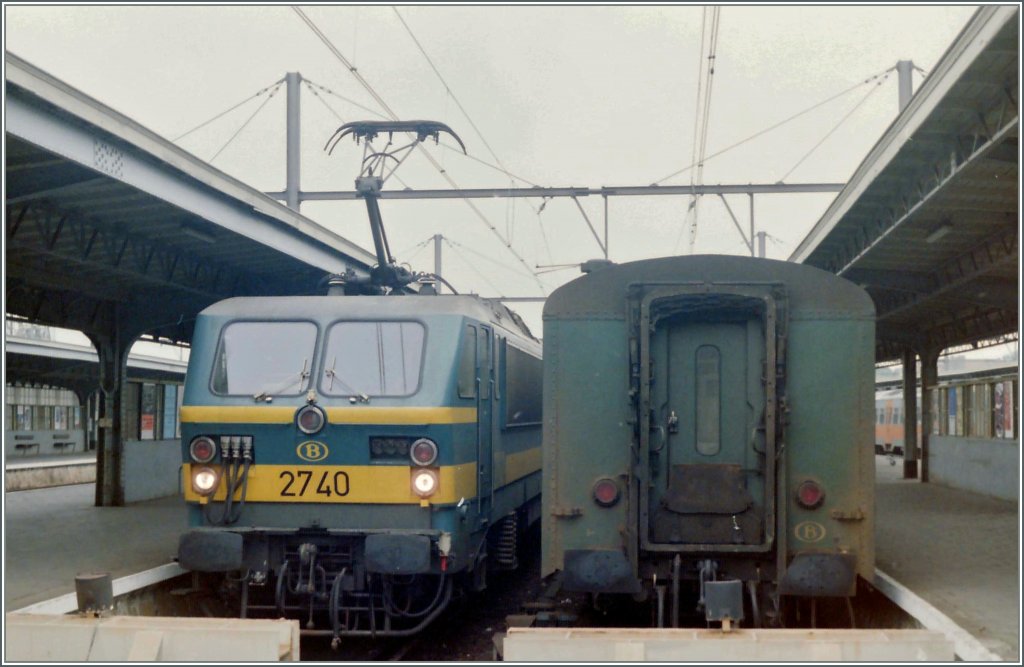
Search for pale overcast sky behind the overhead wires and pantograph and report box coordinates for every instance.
[4,4,975,334]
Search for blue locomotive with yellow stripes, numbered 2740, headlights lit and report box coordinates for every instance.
[178,295,541,638]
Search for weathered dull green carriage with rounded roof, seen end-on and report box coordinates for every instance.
[542,255,874,625]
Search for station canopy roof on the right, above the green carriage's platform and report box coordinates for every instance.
[790,6,1020,362]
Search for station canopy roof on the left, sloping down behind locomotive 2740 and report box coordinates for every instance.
[4,53,376,341]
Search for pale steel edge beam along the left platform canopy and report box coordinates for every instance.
[5,53,375,273]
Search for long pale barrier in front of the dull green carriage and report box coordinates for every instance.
[502,627,953,663]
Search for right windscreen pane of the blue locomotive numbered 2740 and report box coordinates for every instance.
[321,322,425,397]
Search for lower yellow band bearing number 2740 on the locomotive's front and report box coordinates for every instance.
[182,463,476,505]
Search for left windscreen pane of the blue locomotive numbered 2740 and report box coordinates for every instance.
[211,322,316,397]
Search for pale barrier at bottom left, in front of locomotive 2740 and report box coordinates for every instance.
[4,613,299,663]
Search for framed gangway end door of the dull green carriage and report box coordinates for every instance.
[635,284,784,552]
